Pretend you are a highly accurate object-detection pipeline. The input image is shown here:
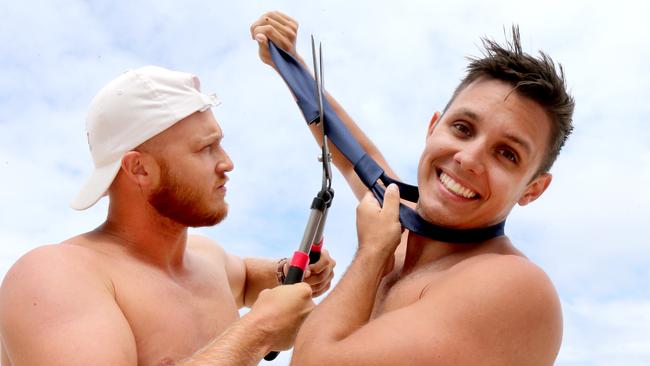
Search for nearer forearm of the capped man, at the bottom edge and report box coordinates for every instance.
[176,313,271,366]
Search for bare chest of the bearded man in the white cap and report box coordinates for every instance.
[110,262,239,365]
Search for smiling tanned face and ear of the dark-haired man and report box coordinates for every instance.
[418,79,551,228]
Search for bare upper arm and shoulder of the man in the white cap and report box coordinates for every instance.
[0,249,137,366]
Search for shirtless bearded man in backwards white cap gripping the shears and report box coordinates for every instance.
[0,66,334,366]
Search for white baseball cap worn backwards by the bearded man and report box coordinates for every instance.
[70,66,219,210]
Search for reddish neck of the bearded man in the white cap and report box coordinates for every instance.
[95,205,187,271]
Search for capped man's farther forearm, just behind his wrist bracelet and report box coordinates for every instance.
[243,258,279,307]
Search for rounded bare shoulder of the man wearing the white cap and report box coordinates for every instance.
[0,240,136,364]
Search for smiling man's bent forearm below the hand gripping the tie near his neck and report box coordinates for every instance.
[294,252,383,352]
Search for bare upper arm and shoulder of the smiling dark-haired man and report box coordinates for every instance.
[294,256,561,366]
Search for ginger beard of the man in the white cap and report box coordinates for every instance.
[148,159,228,227]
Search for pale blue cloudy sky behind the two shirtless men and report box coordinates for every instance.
[0,0,650,366]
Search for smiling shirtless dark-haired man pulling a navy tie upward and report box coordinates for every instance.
[251,12,574,366]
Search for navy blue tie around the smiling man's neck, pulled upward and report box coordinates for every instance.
[269,41,505,243]
